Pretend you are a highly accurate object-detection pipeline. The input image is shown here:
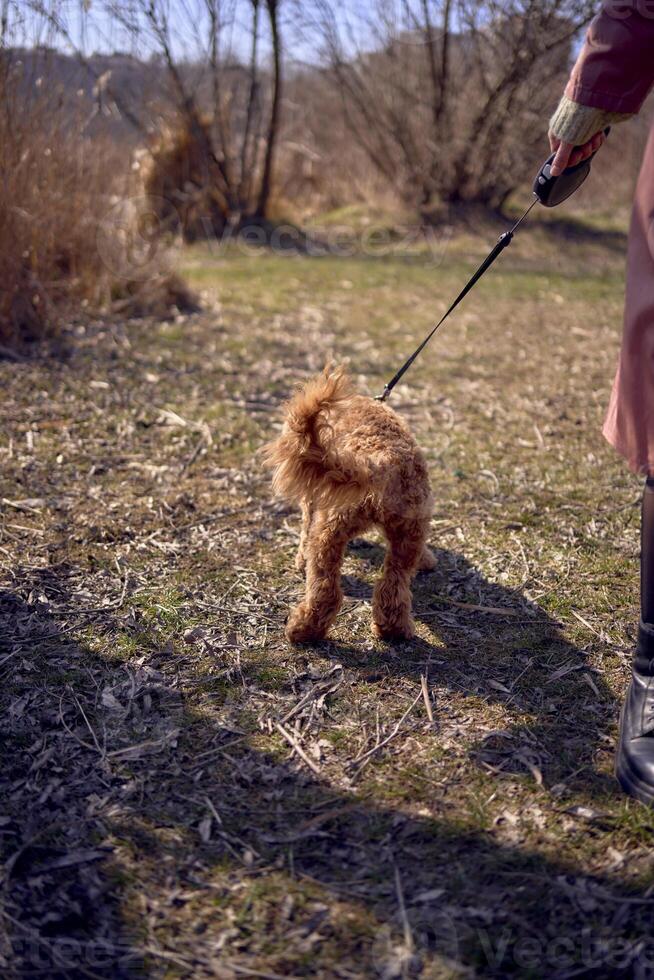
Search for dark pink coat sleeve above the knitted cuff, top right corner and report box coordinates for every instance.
[565,0,654,113]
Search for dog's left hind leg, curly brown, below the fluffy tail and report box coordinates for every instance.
[286,511,369,643]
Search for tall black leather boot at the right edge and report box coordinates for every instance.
[615,477,654,806]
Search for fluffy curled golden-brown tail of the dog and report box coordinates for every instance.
[264,368,371,507]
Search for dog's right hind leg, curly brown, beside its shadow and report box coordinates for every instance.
[372,520,429,640]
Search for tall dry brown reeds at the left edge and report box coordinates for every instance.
[0,52,195,349]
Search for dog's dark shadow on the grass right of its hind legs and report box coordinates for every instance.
[340,539,618,796]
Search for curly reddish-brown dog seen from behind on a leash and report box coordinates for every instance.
[264,368,435,643]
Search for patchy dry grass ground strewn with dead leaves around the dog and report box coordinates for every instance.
[0,211,654,978]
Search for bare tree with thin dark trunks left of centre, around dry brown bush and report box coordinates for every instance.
[28,0,282,238]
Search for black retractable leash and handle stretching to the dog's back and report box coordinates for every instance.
[375,126,611,402]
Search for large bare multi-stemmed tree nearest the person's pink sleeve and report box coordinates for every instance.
[301,0,596,213]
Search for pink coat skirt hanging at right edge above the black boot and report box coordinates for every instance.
[603,127,654,475]
